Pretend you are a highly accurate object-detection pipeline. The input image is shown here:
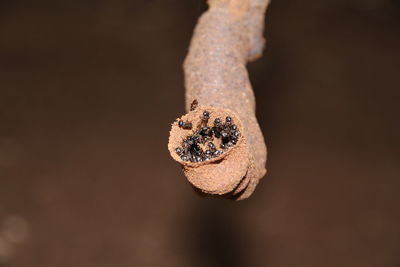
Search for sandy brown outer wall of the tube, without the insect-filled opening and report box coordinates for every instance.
[169,0,269,199]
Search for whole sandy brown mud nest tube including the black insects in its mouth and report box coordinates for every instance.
[168,0,269,200]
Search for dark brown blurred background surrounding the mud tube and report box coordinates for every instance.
[0,0,400,267]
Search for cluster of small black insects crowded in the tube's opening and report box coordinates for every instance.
[175,111,240,162]
